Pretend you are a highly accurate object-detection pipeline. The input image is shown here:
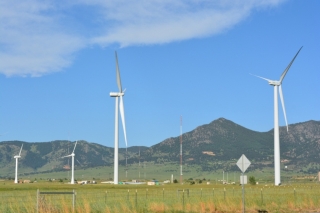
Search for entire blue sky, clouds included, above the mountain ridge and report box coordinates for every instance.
[0,0,320,147]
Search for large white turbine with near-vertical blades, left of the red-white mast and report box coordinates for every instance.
[110,52,128,184]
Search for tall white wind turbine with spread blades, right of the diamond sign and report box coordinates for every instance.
[252,47,302,186]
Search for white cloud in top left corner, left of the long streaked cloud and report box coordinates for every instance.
[0,0,85,77]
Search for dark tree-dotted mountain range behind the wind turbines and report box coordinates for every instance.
[0,118,320,177]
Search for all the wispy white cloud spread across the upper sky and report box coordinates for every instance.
[0,0,282,76]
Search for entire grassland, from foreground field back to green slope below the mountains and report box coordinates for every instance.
[0,163,320,213]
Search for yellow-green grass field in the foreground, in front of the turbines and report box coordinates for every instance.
[0,181,320,213]
